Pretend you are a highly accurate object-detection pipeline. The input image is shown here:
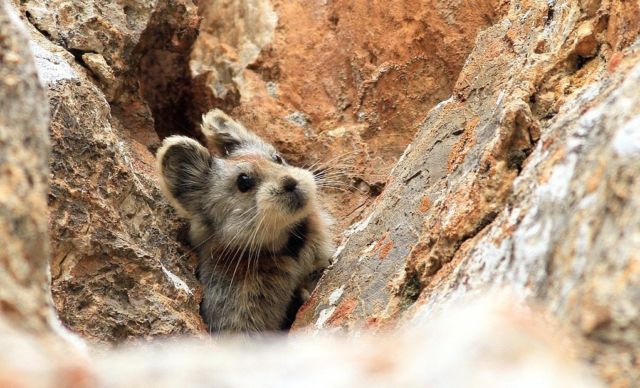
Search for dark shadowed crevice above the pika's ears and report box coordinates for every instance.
[131,1,245,144]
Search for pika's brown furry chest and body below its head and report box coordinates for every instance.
[198,220,316,332]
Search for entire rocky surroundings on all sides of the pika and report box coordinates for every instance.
[0,0,640,387]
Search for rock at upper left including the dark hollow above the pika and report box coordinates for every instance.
[19,0,199,139]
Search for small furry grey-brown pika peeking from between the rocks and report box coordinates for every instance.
[156,109,334,333]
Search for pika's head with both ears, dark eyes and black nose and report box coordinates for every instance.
[157,109,316,249]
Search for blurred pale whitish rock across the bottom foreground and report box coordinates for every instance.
[0,297,601,388]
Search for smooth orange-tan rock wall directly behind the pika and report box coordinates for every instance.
[191,0,504,231]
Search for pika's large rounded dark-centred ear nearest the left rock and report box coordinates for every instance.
[156,136,215,217]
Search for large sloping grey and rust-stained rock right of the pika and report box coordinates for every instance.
[297,1,640,386]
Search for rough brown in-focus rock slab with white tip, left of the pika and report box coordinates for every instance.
[15,4,204,342]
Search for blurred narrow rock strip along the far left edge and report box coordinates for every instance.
[0,3,53,333]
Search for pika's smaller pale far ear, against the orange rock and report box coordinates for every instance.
[201,109,272,157]
